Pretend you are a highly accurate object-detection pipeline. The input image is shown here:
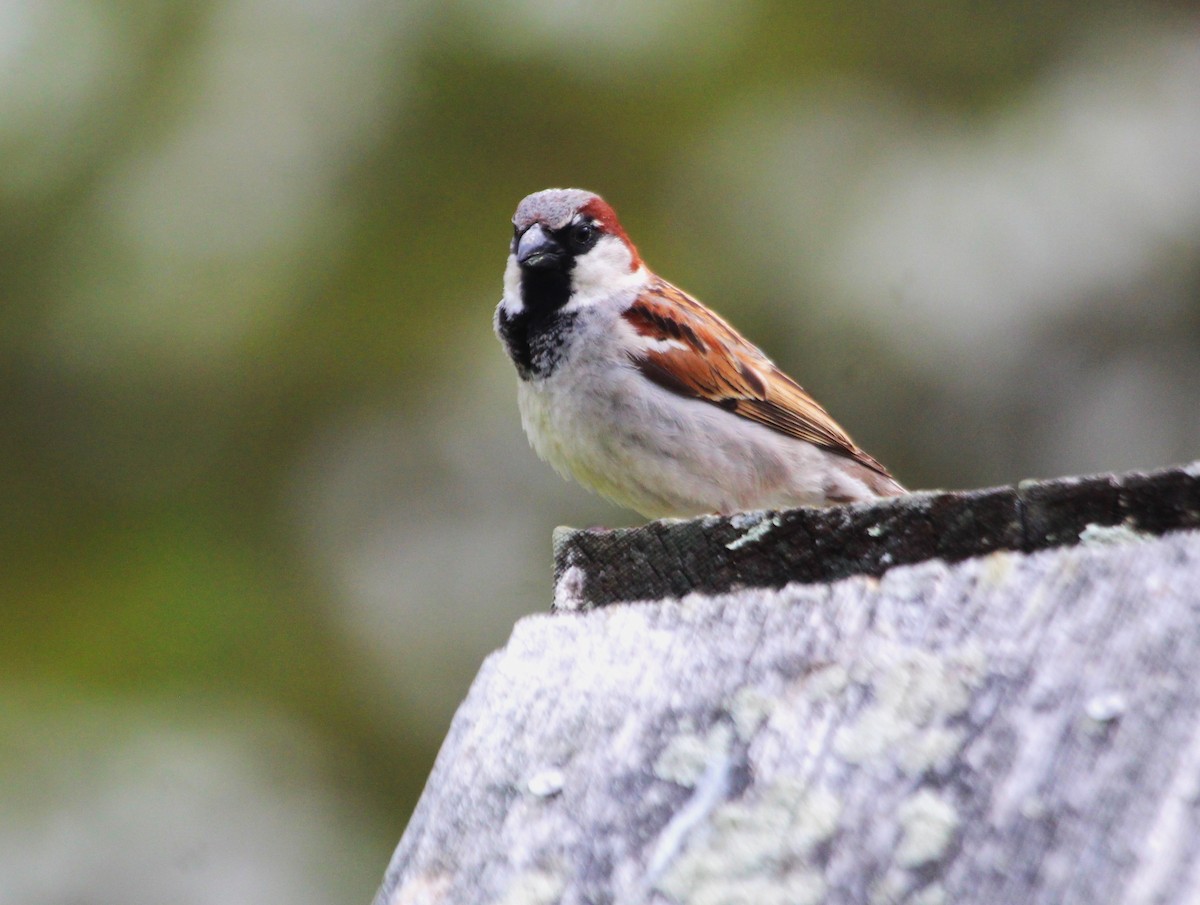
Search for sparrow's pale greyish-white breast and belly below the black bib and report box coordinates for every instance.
[518,300,828,517]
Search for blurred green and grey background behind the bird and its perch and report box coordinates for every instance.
[0,0,1200,905]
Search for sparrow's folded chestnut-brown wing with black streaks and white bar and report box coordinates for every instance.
[624,278,890,477]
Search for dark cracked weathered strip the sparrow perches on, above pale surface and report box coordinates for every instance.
[554,461,1200,611]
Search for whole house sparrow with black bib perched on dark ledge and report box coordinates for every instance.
[494,188,905,519]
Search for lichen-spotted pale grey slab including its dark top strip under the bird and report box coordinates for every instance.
[377,458,1200,905]
